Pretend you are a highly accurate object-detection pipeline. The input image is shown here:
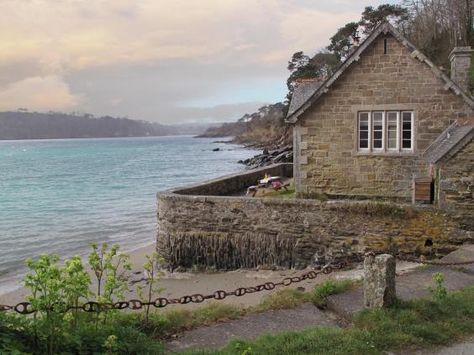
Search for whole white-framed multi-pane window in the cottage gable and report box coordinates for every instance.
[358,111,413,152]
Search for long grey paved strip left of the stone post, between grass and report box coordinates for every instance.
[168,304,338,350]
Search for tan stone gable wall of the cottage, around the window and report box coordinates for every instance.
[294,34,472,199]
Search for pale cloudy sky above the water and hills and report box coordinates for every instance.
[0,0,387,123]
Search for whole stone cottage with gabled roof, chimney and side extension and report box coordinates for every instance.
[287,23,474,216]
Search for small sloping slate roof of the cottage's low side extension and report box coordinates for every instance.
[423,118,474,164]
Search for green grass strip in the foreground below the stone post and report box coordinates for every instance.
[184,286,474,355]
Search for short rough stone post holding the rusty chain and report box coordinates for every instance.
[364,254,396,308]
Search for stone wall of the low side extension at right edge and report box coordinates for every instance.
[437,137,474,231]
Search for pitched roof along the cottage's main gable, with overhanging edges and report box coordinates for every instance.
[286,22,474,123]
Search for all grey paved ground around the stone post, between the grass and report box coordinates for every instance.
[168,245,474,355]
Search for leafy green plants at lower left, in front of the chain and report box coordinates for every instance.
[0,244,170,354]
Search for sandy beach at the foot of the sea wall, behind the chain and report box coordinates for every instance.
[0,244,418,310]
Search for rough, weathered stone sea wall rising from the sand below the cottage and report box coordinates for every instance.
[157,191,472,270]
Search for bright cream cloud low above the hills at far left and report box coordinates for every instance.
[0,76,80,111]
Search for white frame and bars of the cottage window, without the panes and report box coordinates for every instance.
[356,110,415,154]
